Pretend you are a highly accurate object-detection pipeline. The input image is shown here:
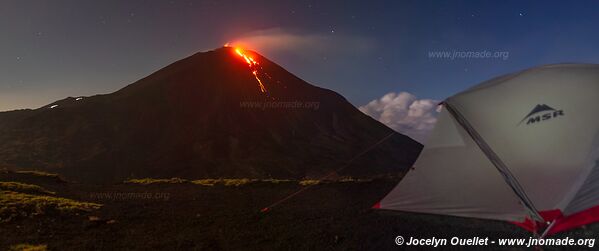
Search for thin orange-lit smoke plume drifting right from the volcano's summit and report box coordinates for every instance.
[229,28,376,54]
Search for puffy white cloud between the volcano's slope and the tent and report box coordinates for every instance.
[359,92,439,143]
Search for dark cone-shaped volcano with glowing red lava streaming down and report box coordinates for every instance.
[0,47,422,182]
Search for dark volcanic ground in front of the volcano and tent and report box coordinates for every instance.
[0,171,597,250]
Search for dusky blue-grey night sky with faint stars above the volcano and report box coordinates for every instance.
[0,0,599,110]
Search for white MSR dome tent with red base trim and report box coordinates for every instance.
[375,64,599,234]
